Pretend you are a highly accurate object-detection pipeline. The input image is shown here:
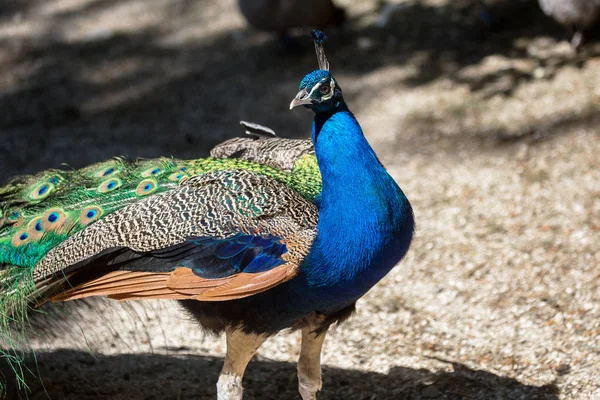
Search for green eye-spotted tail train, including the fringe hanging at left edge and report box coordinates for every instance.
[0,139,321,390]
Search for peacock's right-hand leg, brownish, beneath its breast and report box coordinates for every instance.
[298,325,327,400]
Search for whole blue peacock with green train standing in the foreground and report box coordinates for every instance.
[0,31,415,400]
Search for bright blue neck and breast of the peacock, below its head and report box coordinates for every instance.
[304,103,414,297]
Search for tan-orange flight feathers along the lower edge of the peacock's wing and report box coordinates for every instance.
[51,262,298,301]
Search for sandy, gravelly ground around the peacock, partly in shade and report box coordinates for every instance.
[0,0,600,400]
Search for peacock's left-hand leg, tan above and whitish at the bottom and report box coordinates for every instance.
[217,330,266,400]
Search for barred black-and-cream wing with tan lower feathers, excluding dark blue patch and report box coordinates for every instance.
[34,171,318,301]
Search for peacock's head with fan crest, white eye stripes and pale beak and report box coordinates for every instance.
[290,31,344,113]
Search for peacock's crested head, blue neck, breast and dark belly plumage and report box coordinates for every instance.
[185,29,414,334]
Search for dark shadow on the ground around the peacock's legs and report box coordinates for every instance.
[2,350,558,400]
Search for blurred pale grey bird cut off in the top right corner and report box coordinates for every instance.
[538,0,600,49]
